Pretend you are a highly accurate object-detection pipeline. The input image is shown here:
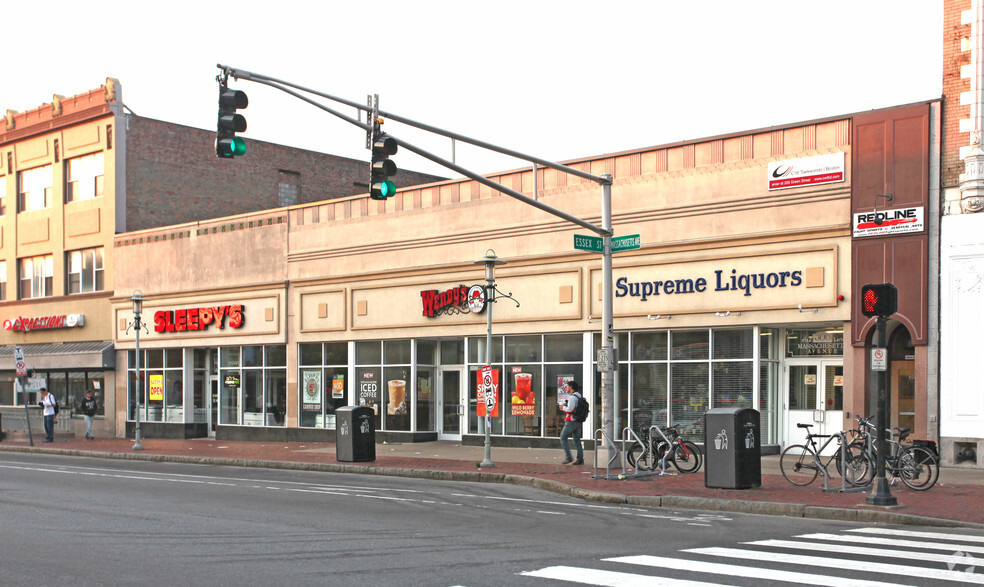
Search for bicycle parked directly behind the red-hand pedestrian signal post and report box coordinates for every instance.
[848,416,940,491]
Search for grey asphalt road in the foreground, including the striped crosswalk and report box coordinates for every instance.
[0,453,984,586]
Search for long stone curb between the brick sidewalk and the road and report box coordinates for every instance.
[7,446,984,529]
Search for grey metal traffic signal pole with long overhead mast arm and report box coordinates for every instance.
[216,63,618,462]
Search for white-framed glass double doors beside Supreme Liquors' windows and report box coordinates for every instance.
[783,359,844,452]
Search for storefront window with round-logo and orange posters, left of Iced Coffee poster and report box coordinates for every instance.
[298,342,348,429]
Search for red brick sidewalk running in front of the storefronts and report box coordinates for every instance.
[0,438,984,528]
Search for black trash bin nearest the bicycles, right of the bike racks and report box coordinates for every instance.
[704,408,762,489]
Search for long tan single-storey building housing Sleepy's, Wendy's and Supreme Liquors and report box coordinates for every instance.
[112,101,941,449]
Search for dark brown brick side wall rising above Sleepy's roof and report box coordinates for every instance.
[126,116,440,231]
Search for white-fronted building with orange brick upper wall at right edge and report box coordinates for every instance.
[939,0,984,467]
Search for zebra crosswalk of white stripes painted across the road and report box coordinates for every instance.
[521,527,984,587]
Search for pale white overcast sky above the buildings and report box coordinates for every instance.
[0,0,943,183]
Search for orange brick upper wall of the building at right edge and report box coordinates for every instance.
[941,0,971,188]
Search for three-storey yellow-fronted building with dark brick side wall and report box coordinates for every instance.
[0,79,437,434]
